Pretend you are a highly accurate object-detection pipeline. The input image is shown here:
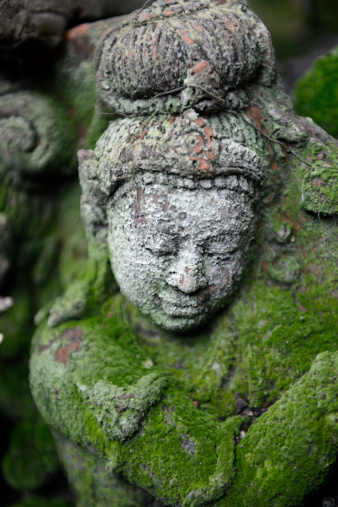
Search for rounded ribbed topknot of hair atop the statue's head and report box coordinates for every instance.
[96,0,275,115]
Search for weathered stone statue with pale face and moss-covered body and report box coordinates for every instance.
[31,0,338,507]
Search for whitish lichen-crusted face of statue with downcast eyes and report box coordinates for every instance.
[108,181,254,331]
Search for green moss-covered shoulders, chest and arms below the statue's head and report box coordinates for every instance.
[31,124,338,506]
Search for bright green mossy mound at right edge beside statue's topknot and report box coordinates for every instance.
[293,48,338,137]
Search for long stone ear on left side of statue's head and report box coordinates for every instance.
[78,150,107,243]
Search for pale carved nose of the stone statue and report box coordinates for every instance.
[167,250,207,294]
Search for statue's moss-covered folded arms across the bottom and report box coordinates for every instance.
[31,319,338,506]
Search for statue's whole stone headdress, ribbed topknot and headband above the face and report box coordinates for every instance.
[79,0,288,244]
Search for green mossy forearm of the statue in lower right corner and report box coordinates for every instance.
[220,353,338,507]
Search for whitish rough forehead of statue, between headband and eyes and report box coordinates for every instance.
[108,185,252,242]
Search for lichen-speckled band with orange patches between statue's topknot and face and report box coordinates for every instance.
[79,110,268,192]
